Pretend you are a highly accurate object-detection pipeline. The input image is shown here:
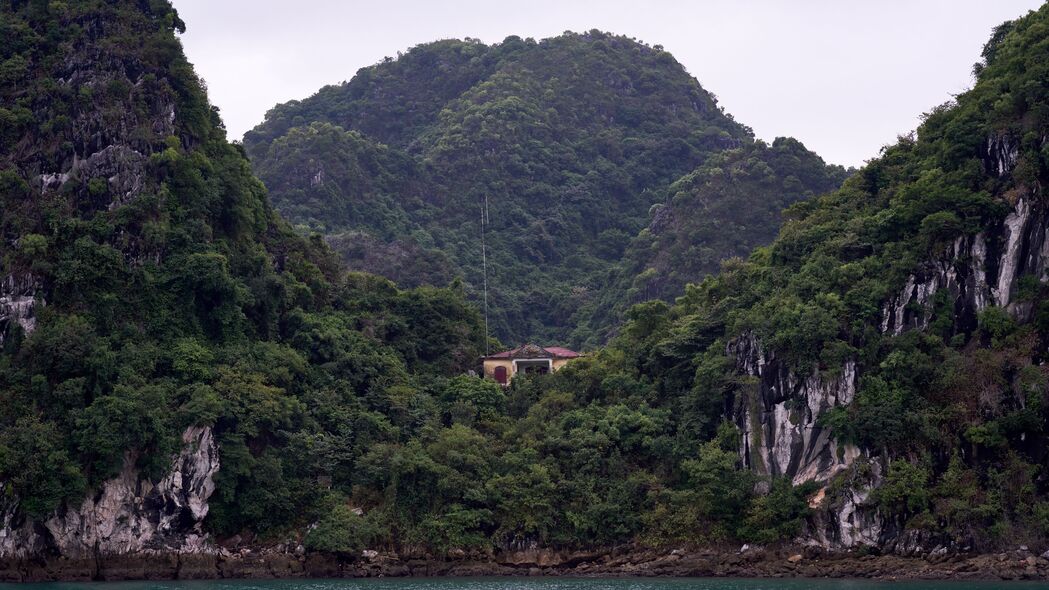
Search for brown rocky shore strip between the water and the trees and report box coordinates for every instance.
[0,547,1049,582]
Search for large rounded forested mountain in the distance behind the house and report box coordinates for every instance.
[244,31,844,345]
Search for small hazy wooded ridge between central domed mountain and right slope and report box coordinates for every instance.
[572,138,849,345]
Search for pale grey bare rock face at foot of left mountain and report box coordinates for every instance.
[0,426,219,560]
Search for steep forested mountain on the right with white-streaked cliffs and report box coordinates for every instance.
[535,5,1049,555]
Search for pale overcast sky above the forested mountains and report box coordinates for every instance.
[173,0,1042,166]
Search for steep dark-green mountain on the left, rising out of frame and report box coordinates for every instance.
[0,0,484,558]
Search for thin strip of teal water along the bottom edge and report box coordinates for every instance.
[0,577,1049,590]
